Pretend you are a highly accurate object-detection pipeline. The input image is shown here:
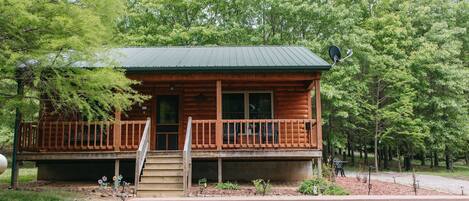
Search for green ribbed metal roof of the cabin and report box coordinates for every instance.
[103,46,331,72]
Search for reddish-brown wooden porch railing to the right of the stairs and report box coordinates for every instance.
[192,119,318,149]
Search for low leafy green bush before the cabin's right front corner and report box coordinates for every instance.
[298,177,349,195]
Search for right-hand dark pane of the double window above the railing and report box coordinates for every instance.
[249,93,272,119]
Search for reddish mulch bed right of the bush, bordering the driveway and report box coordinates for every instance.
[336,177,451,195]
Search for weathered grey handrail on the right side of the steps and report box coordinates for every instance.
[182,117,192,196]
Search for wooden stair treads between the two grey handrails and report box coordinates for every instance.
[137,151,184,197]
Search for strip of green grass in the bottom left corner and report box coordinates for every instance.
[0,190,78,201]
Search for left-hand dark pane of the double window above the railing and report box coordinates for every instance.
[222,93,244,119]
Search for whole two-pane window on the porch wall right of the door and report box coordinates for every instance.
[222,92,273,119]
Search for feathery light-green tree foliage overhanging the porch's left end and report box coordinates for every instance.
[0,0,147,130]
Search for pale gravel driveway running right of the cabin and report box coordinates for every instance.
[346,171,469,195]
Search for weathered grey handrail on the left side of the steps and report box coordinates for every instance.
[135,118,151,192]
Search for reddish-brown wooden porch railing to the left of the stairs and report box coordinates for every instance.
[19,120,146,151]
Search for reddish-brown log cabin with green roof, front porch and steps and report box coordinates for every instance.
[18,46,331,196]
